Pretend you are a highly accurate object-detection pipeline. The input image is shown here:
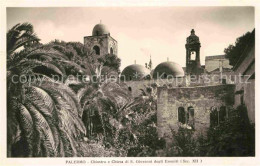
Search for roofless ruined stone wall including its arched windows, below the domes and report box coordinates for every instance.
[157,84,235,142]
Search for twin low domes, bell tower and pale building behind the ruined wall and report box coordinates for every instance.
[121,29,233,97]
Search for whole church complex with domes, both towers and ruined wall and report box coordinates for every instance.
[84,23,254,141]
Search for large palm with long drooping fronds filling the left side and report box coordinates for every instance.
[7,23,86,157]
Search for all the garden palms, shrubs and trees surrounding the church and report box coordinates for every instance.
[7,23,255,157]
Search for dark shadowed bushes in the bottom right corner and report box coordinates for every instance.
[204,105,255,156]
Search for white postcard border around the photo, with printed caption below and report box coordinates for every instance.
[0,0,260,166]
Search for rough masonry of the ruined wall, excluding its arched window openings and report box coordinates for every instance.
[157,85,235,141]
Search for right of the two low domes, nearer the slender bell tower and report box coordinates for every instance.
[153,62,184,79]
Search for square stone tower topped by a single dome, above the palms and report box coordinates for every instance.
[84,23,118,55]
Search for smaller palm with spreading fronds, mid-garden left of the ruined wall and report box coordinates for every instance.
[78,80,136,137]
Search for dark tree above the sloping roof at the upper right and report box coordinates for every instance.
[224,32,254,66]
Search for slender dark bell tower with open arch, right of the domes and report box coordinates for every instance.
[185,29,203,75]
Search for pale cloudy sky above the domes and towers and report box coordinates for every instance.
[7,7,255,71]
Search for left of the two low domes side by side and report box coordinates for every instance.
[121,64,150,81]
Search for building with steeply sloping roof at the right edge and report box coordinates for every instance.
[233,30,255,123]
